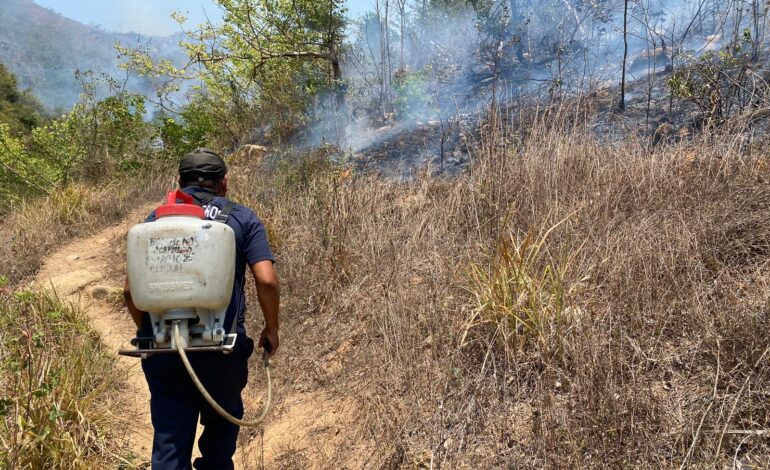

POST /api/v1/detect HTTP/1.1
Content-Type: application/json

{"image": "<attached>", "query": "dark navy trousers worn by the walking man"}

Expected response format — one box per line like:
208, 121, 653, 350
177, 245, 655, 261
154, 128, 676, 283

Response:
142, 335, 254, 470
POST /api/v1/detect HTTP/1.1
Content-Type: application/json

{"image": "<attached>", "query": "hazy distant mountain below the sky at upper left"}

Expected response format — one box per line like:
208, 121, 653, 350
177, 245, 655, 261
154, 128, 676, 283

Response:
0, 0, 186, 110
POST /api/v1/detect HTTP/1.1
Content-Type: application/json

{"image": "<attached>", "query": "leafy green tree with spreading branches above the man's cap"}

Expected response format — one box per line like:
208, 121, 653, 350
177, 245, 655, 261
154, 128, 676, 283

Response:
119, 0, 345, 145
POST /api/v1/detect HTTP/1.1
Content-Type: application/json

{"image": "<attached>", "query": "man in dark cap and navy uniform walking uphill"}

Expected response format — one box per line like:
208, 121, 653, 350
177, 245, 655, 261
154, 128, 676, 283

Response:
124, 148, 279, 470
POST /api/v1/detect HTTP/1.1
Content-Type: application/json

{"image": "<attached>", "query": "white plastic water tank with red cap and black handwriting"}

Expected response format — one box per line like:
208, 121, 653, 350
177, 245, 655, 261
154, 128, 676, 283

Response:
127, 191, 235, 313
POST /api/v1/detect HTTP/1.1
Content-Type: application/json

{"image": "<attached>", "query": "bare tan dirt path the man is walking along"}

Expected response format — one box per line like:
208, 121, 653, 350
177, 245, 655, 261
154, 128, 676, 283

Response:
34, 207, 372, 469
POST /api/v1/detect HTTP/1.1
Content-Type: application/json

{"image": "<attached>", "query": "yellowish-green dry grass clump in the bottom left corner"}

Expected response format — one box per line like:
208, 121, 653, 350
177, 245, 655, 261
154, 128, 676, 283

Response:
0, 292, 124, 469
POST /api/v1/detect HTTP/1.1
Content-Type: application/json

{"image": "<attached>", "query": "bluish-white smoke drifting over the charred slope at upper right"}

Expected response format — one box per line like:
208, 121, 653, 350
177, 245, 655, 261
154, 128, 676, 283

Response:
295, 0, 764, 160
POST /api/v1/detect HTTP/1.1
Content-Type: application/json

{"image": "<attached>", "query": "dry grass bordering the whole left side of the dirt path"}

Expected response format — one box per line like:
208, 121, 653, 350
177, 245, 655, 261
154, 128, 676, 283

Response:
0, 160, 172, 469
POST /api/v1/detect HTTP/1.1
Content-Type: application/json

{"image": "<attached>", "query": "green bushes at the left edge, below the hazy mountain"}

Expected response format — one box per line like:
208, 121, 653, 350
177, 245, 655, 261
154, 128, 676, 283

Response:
0, 89, 153, 207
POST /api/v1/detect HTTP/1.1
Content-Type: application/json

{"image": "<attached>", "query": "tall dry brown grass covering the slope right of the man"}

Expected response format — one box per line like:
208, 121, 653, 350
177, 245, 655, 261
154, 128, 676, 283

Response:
232, 104, 770, 468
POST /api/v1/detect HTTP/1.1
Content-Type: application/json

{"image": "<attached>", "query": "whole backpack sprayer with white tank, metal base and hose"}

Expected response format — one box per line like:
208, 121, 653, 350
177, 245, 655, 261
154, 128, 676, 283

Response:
118, 190, 273, 427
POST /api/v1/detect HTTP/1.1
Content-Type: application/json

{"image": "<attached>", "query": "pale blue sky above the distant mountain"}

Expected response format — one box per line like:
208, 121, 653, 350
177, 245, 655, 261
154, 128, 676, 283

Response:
33, 0, 375, 36
